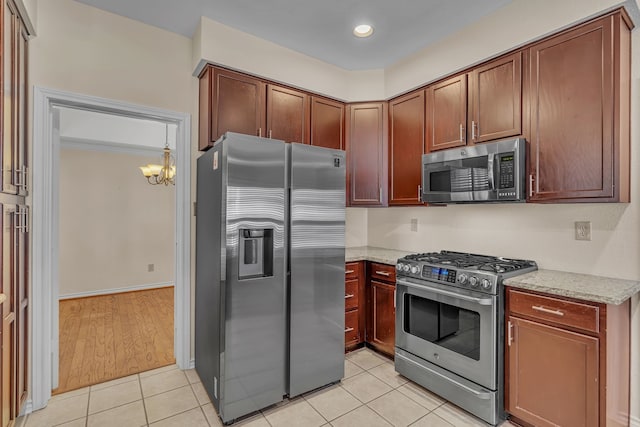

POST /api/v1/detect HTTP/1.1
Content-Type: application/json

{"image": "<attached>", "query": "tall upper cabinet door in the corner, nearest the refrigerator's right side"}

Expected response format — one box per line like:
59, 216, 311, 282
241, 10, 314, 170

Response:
346, 102, 387, 206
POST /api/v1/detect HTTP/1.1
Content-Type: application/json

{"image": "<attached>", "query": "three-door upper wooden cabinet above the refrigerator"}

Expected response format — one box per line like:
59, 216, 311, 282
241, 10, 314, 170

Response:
198, 65, 344, 151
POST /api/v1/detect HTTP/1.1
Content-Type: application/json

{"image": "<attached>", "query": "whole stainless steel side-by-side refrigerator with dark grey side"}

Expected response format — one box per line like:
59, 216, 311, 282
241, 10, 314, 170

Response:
195, 133, 345, 423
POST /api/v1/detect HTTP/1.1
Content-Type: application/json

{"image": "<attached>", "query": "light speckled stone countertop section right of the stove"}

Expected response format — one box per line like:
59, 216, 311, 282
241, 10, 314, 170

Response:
504, 270, 640, 305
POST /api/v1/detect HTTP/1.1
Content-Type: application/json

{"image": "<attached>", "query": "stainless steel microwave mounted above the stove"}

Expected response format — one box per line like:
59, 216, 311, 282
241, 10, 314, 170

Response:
421, 138, 526, 204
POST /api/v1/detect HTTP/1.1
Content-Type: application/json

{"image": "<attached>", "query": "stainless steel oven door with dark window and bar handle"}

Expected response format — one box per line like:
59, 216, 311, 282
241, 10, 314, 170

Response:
396, 278, 498, 390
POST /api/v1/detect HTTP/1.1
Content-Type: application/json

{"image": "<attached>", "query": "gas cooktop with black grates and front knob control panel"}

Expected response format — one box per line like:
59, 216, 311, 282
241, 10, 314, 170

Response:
396, 251, 538, 294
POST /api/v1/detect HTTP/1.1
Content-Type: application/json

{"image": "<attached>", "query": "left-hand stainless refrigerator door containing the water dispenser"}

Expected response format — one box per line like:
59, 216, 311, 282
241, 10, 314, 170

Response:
220, 134, 287, 422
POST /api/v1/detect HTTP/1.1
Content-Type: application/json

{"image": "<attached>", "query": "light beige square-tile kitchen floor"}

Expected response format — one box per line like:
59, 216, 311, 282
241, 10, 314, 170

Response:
17, 349, 510, 427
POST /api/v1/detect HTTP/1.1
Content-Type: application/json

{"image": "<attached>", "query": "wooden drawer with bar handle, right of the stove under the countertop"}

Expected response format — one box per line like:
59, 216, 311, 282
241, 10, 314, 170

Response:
509, 289, 600, 333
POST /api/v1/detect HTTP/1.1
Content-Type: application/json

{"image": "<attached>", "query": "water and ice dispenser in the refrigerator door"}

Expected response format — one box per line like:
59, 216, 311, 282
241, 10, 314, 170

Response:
238, 228, 273, 279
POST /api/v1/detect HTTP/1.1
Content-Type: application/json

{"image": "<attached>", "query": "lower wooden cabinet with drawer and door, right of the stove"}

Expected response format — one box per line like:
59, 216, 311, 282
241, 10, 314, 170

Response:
505, 288, 630, 427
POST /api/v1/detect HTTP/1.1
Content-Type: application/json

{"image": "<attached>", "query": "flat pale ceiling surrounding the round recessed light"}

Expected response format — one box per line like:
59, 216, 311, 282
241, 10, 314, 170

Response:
77, 0, 512, 70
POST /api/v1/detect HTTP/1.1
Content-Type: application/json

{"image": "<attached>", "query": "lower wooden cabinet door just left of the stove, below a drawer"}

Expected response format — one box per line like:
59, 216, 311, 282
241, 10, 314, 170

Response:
367, 280, 396, 355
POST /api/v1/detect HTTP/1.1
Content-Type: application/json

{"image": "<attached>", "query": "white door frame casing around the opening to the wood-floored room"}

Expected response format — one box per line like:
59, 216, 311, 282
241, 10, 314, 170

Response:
30, 86, 191, 413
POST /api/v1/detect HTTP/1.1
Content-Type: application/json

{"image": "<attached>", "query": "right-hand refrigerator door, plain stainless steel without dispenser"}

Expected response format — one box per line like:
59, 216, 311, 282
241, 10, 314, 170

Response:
289, 144, 345, 396
